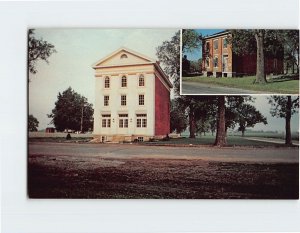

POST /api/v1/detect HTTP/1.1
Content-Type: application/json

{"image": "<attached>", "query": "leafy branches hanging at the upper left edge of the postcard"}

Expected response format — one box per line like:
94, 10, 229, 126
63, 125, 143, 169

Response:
28, 29, 56, 78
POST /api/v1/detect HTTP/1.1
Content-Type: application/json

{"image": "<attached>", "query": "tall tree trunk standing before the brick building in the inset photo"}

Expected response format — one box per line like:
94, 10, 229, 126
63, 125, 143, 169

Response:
255, 30, 267, 84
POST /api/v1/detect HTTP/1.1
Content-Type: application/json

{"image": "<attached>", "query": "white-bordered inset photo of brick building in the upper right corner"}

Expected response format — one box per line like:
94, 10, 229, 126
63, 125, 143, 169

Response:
180, 29, 299, 95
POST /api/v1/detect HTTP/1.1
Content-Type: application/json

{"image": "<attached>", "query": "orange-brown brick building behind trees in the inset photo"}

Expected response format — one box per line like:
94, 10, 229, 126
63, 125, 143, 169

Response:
202, 31, 283, 77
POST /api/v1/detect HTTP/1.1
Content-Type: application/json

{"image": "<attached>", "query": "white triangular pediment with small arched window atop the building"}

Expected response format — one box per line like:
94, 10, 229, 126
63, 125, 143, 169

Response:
93, 48, 155, 68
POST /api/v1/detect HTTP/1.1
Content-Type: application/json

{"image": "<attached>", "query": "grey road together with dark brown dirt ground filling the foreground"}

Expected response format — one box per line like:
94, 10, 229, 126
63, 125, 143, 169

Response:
28, 143, 299, 199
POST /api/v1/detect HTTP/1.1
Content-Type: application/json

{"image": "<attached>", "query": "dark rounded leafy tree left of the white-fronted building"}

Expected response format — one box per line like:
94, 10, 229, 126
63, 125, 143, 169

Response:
48, 87, 94, 132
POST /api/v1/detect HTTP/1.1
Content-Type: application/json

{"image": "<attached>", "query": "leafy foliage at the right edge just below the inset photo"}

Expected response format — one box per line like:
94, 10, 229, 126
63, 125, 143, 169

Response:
269, 95, 299, 118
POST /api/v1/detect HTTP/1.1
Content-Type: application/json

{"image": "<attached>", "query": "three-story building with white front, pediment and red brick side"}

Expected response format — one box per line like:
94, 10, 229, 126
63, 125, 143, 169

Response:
93, 48, 172, 141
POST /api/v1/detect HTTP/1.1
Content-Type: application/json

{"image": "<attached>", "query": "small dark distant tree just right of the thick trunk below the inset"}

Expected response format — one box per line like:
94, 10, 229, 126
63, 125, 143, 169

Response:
237, 103, 267, 137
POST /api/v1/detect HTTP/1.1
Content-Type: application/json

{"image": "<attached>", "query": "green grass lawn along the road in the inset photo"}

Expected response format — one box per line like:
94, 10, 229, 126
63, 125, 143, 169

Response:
182, 76, 299, 94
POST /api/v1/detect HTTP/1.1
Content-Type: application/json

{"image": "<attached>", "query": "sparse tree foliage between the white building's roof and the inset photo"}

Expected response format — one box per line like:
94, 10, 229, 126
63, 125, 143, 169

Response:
156, 31, 180, 95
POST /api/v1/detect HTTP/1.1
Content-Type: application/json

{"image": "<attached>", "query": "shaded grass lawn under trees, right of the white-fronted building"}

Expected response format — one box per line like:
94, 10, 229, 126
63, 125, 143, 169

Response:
145, 135, 290, 147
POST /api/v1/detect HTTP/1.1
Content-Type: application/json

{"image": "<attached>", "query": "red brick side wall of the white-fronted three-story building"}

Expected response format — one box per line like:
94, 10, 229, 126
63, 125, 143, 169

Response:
155, 77, 170, 136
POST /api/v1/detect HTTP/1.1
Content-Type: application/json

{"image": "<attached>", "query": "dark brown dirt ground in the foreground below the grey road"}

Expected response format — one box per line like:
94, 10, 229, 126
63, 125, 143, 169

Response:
28, 151, 299, 199
